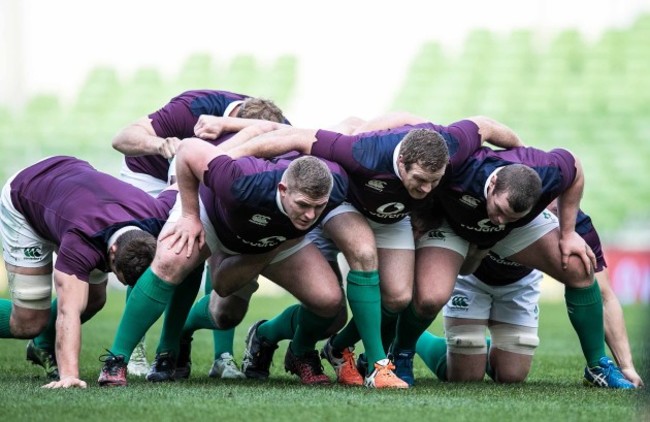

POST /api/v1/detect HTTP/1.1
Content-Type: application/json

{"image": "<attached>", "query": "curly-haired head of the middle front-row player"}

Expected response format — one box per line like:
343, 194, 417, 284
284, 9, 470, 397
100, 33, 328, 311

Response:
397, 129, 449, 199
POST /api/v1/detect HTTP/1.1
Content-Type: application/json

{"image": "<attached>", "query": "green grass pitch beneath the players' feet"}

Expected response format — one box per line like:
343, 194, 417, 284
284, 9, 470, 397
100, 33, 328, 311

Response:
0, 291, 649, 421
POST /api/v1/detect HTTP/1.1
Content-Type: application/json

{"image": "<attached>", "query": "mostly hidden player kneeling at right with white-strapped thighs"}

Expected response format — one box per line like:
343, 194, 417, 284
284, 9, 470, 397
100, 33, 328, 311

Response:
416, 207, 643, 387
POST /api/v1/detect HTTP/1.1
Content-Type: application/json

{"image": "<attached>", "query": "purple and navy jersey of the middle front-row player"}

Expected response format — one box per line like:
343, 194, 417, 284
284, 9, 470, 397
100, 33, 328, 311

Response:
311, 120, 481, 224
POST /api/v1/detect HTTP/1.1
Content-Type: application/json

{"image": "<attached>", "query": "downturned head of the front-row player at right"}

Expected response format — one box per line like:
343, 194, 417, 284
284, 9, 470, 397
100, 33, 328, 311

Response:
486, 164, 542, 225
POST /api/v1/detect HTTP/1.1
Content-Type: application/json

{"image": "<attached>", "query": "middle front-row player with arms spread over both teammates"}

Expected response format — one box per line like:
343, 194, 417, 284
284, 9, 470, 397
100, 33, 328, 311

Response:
205, 113, 520, 388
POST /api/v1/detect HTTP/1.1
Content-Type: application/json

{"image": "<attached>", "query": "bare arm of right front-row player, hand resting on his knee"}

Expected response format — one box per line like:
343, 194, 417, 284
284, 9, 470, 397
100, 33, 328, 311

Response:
557, 157, 596, 274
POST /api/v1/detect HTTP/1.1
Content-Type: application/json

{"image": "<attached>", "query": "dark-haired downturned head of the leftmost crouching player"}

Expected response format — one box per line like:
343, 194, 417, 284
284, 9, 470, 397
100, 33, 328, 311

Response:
110, 230, 156, 286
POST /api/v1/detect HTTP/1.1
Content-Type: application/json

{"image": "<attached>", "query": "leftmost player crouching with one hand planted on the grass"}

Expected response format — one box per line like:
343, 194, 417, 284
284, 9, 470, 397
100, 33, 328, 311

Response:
0, 156, 176, 388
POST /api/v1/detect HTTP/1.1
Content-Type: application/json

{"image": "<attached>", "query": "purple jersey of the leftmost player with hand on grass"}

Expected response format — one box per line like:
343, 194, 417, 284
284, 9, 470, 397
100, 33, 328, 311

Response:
11, 156, 176, 281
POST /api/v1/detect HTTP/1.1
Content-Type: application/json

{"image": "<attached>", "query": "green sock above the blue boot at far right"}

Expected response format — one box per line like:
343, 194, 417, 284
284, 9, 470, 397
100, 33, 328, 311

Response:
564, 280, 605, 367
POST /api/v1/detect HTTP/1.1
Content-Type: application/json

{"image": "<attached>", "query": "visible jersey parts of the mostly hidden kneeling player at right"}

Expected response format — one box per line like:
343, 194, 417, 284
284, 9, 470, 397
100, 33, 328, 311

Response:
474, 211, 607, 286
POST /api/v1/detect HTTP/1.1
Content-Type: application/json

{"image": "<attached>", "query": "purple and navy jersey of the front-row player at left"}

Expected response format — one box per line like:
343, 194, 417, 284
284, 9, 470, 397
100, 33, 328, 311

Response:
199, 155, 348, 254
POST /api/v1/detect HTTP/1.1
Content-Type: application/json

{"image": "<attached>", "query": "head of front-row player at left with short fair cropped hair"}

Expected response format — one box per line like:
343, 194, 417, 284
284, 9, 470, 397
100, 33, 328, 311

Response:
278, 156, 334, 230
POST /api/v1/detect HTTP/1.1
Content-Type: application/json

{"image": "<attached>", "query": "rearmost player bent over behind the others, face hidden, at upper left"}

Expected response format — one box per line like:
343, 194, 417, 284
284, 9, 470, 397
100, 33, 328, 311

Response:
113, 90, 286, 378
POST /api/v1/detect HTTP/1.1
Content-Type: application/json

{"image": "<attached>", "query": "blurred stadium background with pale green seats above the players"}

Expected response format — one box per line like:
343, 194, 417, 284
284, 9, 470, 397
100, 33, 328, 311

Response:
0, 0, 650, 303
